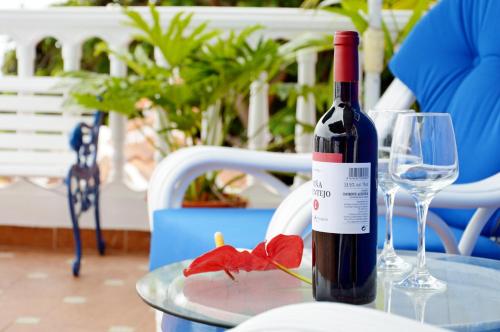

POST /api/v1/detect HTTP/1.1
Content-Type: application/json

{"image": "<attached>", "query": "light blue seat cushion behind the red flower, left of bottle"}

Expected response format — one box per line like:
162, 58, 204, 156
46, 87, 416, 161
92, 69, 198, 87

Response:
149, 209, 274, 270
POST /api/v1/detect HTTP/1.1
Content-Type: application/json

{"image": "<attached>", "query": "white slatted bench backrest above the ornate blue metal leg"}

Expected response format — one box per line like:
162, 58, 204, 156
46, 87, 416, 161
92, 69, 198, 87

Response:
0, 77, 92, 177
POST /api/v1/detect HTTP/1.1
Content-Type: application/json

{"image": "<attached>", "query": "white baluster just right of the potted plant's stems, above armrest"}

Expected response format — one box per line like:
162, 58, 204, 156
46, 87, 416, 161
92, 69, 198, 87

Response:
248, 72, 271, 150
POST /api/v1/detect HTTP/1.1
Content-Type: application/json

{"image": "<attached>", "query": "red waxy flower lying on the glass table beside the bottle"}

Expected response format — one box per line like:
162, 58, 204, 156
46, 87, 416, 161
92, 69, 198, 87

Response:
184, 234, 304, 277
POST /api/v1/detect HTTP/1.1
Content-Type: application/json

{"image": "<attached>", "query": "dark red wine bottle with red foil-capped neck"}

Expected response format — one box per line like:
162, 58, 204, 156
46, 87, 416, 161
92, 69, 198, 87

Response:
312, 31, 377, 304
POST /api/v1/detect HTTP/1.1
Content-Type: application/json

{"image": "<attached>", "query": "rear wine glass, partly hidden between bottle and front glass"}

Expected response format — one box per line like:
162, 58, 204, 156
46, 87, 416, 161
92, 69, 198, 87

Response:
368, 110, 414, 272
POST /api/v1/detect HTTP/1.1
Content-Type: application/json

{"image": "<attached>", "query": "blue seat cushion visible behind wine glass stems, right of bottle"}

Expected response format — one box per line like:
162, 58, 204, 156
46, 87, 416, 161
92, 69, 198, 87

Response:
377, 216, 500, 259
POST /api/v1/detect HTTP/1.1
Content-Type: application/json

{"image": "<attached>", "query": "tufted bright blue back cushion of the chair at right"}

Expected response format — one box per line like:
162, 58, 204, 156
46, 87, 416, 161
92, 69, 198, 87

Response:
390, 0, 500, 235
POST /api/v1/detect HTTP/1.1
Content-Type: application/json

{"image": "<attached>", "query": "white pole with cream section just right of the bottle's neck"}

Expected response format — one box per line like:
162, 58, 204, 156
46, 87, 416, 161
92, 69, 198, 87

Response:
363, 0, 384, 111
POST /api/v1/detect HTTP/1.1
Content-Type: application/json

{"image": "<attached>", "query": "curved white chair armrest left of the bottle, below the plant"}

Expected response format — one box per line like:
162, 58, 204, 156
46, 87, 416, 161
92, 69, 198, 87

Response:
148, 146, 311, 229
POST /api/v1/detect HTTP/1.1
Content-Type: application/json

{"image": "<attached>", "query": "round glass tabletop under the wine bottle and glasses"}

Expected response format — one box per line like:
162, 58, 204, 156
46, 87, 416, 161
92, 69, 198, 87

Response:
136, 251, 500, 331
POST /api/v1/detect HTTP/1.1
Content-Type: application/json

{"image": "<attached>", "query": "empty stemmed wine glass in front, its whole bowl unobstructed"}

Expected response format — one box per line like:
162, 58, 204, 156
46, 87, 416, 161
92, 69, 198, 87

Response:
389, 113, 458, 291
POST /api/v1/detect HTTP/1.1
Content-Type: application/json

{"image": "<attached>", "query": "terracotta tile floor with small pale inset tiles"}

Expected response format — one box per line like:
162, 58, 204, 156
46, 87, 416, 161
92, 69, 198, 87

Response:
0, 247, 154, 332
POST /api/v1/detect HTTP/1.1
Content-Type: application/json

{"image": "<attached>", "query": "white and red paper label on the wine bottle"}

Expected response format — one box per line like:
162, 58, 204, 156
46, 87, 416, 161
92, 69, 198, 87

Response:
312, 152, 371, 234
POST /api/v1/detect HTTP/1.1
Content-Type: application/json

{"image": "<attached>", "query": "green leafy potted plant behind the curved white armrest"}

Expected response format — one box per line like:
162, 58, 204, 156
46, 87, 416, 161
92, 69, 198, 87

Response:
65, 6, 286, 206
